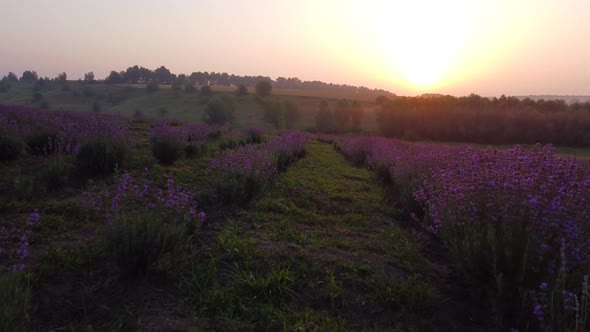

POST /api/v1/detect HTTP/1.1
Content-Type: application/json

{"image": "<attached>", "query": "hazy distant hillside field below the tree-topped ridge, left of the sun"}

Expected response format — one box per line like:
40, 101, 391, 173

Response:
0, 82, 377, 131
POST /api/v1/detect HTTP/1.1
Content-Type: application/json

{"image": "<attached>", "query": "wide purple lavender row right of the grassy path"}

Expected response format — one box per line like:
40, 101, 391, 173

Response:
341, 137, 590, 330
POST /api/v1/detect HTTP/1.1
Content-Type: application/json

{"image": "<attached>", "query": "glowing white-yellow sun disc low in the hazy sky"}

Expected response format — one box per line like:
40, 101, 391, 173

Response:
373, 0, 473, 91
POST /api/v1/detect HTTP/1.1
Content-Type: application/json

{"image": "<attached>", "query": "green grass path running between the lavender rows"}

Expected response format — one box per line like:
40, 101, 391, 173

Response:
189, 141, 435, 331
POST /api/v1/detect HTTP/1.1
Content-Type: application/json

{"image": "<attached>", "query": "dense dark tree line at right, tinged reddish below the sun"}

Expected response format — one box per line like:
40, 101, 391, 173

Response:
376, 94, 590, 146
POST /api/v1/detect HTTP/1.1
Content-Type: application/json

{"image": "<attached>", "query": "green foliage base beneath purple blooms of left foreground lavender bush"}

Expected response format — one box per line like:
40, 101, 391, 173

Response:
106, 211, 186, 278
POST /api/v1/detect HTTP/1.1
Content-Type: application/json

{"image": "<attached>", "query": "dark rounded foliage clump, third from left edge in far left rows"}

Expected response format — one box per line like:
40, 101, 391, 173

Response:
75, 137, 128, 176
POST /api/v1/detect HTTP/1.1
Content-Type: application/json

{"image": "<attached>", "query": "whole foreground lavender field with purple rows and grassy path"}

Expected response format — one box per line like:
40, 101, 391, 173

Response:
0, 102, 590, 331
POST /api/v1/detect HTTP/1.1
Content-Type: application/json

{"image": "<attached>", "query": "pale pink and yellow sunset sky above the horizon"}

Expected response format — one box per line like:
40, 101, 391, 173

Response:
0, 0, 590, 96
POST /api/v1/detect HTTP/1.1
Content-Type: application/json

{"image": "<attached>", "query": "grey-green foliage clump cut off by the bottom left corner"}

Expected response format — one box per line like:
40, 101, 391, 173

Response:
0, 272, 31, 331
